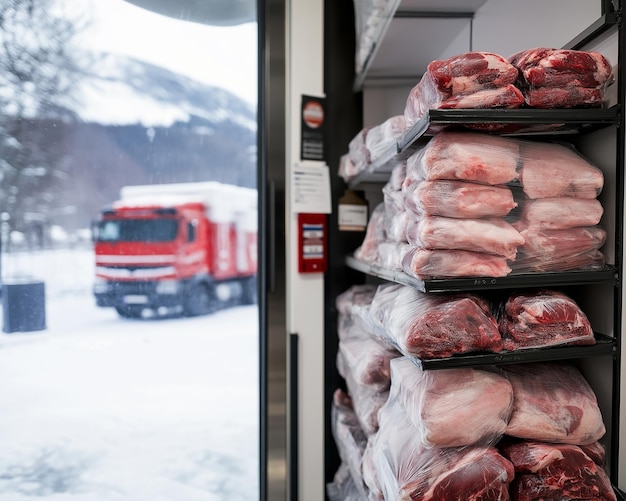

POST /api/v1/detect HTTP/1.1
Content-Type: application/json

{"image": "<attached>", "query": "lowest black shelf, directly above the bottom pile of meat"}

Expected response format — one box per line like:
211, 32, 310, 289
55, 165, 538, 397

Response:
405, 333, 617, 370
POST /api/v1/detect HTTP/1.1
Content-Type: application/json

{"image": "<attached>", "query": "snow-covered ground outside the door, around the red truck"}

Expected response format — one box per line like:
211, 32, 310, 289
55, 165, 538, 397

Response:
0, 250, 259, 501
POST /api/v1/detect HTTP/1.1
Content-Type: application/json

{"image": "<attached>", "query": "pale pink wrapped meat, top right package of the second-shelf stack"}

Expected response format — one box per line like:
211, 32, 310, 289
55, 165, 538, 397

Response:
520, 141, 604, 199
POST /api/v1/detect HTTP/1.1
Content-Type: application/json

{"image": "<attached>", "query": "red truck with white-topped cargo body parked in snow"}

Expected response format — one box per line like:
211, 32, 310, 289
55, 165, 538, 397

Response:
93, 182, 257, 318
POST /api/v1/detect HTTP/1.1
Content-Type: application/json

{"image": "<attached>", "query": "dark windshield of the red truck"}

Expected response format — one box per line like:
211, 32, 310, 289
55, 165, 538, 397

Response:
96, 219, 178, 242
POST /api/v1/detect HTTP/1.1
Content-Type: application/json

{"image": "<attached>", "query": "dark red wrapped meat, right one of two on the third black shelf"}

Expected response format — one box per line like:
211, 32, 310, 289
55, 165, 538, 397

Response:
499, 289, 596, 350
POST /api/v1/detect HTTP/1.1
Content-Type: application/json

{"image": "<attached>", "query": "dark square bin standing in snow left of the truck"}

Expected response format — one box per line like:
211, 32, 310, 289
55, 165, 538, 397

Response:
2, 280, 46, 332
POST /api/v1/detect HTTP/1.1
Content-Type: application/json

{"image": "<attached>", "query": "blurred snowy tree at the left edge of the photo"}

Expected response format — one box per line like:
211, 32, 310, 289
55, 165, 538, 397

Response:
0, 0, 84, 246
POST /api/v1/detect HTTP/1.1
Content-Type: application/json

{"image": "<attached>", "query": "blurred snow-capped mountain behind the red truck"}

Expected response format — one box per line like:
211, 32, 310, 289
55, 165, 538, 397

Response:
37, 55, 257, 230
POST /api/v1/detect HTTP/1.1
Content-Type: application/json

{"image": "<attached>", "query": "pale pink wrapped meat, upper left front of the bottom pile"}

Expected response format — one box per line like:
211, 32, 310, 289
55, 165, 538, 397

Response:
389, 357, 513, 447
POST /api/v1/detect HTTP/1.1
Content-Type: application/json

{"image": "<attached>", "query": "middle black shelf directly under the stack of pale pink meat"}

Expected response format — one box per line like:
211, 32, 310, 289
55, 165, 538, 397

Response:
346, 256, 618, 292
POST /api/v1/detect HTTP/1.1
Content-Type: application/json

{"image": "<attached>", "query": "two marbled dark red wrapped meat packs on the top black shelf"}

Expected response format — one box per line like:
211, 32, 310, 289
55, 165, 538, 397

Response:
404, 47, 614, 132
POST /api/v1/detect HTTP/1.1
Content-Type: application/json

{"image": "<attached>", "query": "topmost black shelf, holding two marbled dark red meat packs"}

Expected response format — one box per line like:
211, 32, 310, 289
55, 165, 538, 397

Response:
398, 105, 619, 153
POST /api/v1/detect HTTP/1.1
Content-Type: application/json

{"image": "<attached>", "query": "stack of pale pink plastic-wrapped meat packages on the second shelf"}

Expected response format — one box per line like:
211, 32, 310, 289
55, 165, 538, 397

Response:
354, 127, 606, 280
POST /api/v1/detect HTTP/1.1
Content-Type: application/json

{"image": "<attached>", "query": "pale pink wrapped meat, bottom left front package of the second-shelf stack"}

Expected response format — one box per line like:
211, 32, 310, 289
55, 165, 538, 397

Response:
402, 247, 512, 280
